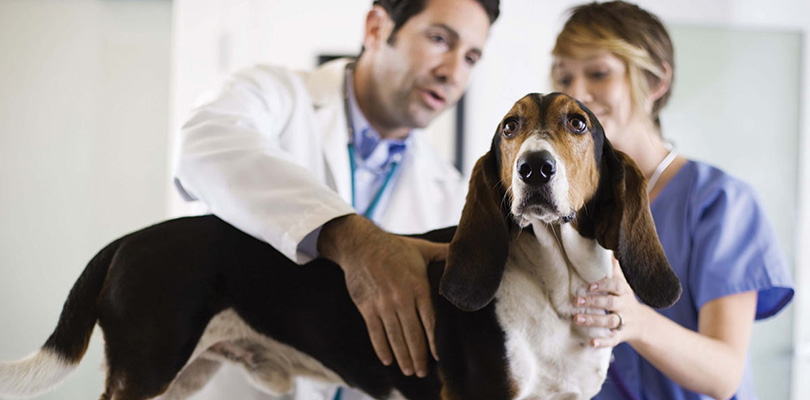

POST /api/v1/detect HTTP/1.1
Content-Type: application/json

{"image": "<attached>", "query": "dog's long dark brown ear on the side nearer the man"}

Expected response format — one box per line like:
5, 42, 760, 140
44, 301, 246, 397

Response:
439, 143, 509, 311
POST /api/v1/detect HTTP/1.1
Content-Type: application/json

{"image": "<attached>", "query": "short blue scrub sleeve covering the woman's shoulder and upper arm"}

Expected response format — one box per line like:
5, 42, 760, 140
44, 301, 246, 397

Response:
687, 161, 793, 319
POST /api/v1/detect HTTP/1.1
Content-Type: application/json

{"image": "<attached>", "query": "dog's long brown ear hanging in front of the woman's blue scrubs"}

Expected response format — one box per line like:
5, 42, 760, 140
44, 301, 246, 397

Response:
580, 133, 681, 308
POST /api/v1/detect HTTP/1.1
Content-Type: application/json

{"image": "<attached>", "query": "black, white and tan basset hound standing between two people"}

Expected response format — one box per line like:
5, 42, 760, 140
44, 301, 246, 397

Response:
0, 94, 681, 400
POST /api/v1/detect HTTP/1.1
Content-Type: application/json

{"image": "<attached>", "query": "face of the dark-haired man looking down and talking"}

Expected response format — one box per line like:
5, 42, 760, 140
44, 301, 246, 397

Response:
366, 0, 489, 128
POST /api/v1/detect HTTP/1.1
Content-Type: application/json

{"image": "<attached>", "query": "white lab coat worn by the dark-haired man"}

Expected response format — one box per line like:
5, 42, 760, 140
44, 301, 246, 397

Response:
175, 59, 466, 400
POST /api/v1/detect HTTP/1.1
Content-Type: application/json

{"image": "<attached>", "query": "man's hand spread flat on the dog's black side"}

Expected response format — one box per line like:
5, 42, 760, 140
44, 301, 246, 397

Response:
318, 214, 448, 377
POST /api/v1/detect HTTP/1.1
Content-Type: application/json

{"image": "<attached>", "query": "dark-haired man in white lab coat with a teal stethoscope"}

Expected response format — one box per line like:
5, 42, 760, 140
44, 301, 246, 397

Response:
175, 0, 498, 400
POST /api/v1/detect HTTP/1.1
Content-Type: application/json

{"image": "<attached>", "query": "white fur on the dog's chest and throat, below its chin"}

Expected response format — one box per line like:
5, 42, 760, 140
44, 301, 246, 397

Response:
495, 223, 612, 399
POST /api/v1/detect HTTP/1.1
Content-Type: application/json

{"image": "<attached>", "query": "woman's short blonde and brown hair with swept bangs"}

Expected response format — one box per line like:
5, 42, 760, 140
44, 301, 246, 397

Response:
552, 1, 675, 127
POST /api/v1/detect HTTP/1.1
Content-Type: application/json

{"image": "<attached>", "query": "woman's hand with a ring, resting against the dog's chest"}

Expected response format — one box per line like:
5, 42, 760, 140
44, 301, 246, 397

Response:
574, 258, 646, 348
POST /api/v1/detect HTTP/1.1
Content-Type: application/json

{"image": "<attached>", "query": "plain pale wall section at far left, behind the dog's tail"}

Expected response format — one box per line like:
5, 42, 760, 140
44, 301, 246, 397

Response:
0, 0, 171, 399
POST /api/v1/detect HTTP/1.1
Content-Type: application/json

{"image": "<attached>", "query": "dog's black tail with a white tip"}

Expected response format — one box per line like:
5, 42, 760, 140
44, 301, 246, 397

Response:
0, 238, 123, 399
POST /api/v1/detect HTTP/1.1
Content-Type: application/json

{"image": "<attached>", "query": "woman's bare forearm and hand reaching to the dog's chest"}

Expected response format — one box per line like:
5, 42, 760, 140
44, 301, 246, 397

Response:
574, 259, 757, 399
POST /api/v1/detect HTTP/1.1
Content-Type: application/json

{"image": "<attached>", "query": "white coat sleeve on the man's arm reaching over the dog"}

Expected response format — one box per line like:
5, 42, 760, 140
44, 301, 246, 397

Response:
175, 68, 354, 262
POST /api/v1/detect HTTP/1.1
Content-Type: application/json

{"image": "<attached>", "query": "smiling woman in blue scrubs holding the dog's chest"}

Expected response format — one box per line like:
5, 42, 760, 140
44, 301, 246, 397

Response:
552, 1, 793, 400
